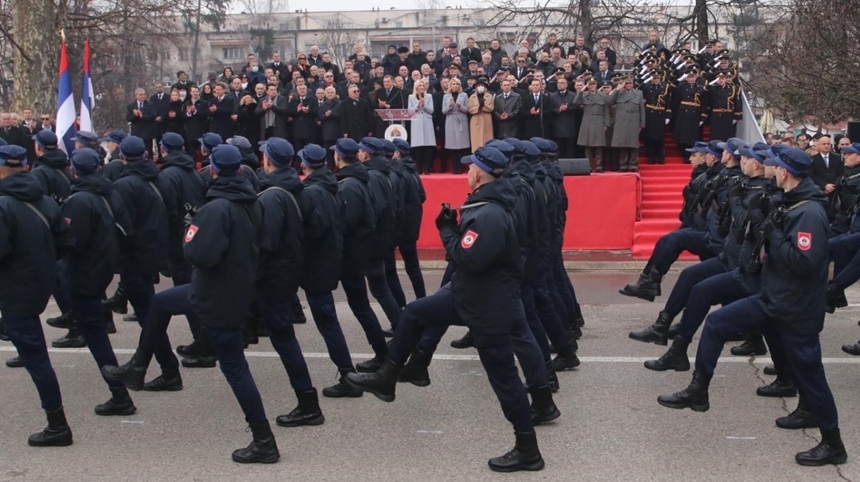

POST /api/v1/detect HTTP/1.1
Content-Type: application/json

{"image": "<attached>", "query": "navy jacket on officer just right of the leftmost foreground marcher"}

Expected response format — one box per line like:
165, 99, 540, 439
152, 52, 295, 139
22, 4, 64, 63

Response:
62, 174, 133, 298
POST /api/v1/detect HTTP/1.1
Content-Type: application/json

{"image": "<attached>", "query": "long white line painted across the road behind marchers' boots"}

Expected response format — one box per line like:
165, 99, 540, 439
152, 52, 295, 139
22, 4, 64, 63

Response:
5, 346, 860, 365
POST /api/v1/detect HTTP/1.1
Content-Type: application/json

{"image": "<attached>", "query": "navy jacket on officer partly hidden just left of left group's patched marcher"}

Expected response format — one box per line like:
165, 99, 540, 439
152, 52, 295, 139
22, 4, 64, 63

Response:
158, 151, 206, 259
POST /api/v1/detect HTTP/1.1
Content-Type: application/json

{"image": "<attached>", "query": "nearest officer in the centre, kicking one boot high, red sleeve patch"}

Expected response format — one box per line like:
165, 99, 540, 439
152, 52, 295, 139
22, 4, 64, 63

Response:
347, 147, 544, 472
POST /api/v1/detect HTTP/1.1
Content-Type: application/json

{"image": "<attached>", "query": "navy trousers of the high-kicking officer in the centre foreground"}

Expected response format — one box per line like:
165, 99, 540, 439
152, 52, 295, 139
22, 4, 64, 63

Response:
388, 285, 546, 432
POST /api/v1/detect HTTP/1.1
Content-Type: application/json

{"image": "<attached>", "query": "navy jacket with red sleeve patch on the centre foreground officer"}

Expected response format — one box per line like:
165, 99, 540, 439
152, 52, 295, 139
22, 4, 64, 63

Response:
439, 178, 523, 334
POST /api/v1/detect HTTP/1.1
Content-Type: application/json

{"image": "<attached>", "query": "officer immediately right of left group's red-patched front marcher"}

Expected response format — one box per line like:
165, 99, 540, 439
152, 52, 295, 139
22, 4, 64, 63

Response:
257, 137, 325, 427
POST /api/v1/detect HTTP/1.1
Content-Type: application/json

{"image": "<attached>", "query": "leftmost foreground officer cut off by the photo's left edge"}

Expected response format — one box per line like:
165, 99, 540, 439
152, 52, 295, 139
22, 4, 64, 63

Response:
0, 145, 74, 447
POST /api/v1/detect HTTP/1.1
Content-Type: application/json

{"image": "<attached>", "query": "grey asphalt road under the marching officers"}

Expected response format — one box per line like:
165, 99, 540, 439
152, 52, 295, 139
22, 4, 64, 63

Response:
0, 271, 860, 482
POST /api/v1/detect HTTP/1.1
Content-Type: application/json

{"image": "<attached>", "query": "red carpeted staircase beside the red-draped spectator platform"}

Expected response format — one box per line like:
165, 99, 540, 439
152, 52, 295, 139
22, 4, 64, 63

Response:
633, 129, 698, 259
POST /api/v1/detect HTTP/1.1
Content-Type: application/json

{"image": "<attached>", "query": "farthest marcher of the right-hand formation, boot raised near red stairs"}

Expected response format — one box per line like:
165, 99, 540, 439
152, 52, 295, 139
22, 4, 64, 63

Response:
619, 141, 727, 306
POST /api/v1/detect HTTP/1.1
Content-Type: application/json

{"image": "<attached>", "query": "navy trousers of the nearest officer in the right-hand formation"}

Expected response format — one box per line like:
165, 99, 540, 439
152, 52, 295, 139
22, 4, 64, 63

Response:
696, 295, 839, 431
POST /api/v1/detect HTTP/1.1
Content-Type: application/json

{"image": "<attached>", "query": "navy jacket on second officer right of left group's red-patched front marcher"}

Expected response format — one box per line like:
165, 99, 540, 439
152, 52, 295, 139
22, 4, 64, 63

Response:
301, 167, 344, 293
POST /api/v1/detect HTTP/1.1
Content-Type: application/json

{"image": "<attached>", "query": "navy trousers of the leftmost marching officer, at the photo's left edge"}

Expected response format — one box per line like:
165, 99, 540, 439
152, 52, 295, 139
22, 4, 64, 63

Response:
2, 313, 63, 412
